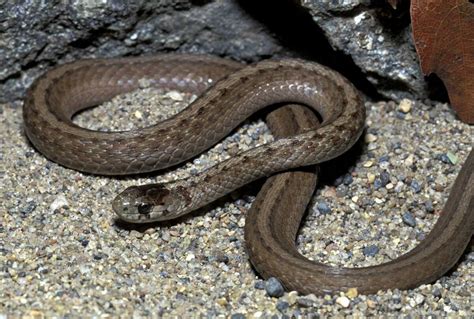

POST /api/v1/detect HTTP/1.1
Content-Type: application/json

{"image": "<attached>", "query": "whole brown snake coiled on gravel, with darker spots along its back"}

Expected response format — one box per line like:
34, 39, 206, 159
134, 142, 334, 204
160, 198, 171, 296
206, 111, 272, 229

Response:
23, 54, 474, 294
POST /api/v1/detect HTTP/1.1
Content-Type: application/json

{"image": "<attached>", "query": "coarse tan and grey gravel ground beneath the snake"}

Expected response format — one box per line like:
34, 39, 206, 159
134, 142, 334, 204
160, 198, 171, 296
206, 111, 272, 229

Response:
0, 89, 474, 318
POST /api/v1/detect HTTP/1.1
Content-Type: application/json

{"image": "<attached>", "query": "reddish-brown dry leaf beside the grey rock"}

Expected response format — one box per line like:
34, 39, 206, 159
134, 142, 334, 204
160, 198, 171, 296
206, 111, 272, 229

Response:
411, 0, 474, 124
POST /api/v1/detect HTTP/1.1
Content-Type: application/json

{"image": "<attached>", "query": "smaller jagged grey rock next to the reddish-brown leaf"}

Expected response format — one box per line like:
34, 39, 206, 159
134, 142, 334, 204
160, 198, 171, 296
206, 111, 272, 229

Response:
302, 0, 429, 100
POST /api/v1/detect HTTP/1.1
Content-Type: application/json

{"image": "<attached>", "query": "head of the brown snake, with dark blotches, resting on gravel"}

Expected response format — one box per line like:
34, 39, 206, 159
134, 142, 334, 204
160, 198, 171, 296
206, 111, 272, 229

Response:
112, 184, 187, 223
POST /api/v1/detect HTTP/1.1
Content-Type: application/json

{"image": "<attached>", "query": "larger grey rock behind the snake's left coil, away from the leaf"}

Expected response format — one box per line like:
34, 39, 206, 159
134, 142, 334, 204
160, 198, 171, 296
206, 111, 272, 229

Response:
0, 0, 282, 102
